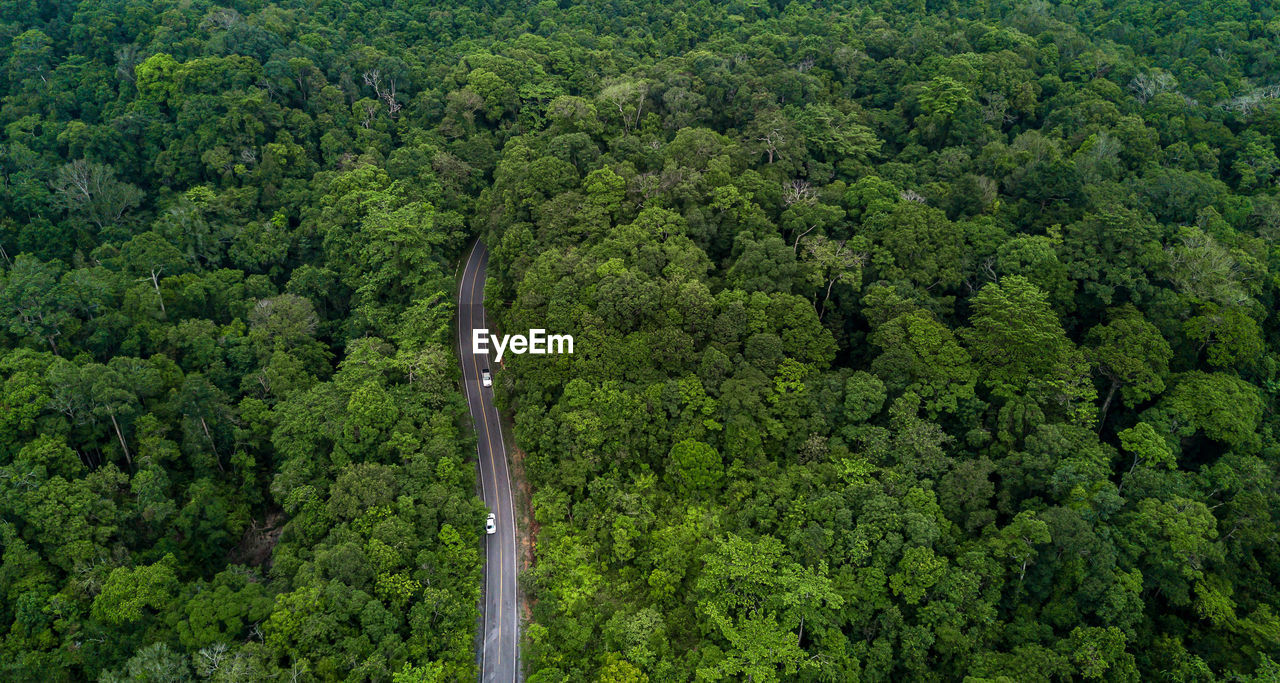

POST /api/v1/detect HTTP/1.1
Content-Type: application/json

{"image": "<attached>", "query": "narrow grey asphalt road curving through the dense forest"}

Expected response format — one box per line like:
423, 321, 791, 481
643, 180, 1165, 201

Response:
458, 242, 520, 683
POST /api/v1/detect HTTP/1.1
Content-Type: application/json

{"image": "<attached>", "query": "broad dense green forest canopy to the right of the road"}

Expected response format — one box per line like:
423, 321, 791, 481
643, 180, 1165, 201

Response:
471, 3, 1280, 683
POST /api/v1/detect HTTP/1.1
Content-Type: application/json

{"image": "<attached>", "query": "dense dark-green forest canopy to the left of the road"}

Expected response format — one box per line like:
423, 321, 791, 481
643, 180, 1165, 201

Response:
0, 1, 484, 680
